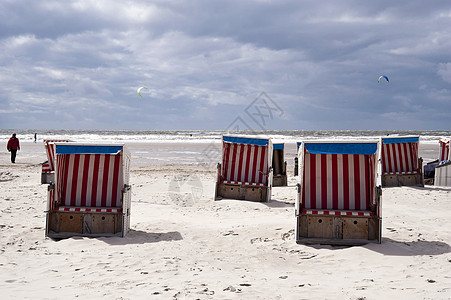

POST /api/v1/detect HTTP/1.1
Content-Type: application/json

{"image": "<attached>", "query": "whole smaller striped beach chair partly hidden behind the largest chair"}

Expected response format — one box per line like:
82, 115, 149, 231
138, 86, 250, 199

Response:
381, 136, 424, 187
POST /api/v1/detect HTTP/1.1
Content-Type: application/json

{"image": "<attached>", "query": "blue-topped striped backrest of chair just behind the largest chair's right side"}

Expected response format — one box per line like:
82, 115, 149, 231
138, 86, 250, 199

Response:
381, 137, 420, 174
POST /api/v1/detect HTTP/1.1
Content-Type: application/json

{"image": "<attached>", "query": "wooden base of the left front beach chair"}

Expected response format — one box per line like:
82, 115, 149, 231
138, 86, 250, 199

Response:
46, 212, 125, 238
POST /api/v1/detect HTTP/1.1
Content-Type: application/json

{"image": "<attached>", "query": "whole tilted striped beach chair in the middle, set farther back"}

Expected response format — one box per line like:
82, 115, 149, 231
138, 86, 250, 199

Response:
215, 136, 273, 202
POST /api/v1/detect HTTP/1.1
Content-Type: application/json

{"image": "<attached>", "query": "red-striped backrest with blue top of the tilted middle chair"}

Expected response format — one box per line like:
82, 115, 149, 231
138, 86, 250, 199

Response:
221, 136, 272, 185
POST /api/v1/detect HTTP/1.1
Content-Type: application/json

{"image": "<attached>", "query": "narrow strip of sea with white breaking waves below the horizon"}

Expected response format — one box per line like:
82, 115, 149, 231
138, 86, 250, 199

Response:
0, 129, 451, 144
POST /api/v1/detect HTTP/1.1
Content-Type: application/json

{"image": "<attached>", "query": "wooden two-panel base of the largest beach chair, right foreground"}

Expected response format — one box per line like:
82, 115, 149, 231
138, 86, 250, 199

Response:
296, 215, 381, 245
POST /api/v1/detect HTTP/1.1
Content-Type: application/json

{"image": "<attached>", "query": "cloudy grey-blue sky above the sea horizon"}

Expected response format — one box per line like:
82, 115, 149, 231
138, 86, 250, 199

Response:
0, 0, 451, 130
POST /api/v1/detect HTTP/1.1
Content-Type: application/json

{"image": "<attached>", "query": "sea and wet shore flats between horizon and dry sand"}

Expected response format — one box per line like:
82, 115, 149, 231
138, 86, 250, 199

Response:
0, 129, 451, 166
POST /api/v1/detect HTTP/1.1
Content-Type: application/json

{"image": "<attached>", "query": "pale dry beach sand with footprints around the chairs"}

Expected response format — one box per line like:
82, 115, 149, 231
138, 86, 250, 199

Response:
0, 143, 451, 299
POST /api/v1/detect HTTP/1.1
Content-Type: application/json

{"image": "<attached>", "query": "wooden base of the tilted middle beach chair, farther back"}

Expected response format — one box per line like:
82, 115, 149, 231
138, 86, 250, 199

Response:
215, 183, 268, 202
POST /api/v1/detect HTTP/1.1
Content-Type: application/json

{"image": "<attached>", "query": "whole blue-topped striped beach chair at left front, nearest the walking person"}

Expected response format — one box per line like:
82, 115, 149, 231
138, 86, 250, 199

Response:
46, 143, 131, 238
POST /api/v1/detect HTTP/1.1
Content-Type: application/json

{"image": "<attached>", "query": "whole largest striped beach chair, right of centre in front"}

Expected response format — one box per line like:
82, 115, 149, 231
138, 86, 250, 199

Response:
295, 141, 382, 245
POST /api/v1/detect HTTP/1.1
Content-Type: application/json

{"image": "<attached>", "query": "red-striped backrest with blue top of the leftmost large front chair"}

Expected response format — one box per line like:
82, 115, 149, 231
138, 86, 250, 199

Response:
55, 143, 128, 207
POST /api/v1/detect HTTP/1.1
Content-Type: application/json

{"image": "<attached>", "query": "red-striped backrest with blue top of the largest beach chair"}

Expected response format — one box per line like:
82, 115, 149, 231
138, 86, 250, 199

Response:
300, 142, 378, 210
